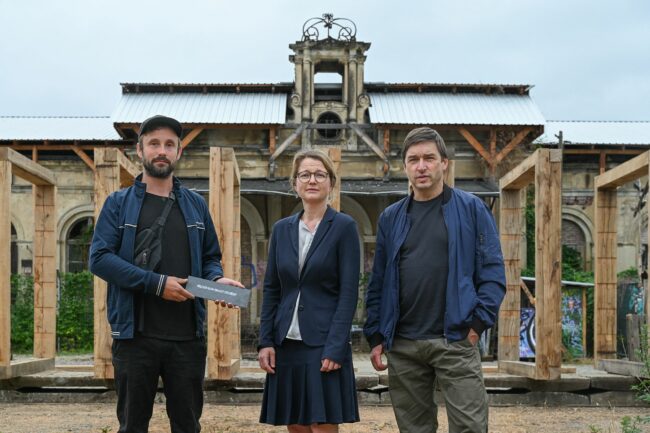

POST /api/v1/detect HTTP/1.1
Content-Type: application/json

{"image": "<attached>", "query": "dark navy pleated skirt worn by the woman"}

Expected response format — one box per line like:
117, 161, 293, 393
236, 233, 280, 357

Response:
260, 340, 359, 425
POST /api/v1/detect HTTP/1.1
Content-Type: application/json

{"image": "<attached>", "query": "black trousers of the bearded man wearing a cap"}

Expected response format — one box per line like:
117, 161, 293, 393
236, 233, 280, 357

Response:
113, 336, 206, 433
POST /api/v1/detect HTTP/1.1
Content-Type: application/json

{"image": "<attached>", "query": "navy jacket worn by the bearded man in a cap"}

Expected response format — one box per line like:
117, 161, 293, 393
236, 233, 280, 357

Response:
90, 175, 223, 339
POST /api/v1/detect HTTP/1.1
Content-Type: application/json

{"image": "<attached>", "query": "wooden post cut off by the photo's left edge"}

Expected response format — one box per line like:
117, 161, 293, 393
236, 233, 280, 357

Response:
0, 160, 11, 368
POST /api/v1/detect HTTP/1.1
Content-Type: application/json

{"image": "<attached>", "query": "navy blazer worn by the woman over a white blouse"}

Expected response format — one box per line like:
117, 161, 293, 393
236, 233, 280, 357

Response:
259, 206, 359, 364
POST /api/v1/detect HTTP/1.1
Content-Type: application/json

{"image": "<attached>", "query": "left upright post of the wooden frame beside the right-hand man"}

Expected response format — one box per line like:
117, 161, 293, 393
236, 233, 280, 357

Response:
498, 189, 526, 361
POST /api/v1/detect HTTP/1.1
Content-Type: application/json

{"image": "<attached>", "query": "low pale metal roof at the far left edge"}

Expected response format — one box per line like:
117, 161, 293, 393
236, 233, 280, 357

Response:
0, 116, 122, 141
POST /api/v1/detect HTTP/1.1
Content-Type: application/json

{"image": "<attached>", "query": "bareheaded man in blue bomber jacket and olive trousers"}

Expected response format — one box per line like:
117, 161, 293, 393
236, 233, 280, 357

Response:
364, 127, 505, 433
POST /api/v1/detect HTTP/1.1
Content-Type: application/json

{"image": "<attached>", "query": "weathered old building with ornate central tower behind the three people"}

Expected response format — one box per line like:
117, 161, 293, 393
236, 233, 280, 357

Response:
0, 17, 650, 354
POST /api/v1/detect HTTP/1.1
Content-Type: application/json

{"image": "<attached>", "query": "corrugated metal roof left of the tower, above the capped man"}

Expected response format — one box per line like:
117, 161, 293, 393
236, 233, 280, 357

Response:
111, 93, 287, 124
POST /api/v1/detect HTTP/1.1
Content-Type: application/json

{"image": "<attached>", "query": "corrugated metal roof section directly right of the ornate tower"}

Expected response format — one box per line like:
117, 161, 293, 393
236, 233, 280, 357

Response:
370, 93, 545, 125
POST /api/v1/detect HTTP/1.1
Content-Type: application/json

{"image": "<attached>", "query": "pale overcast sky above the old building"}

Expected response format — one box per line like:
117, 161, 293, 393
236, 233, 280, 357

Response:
0, 0, 650, 120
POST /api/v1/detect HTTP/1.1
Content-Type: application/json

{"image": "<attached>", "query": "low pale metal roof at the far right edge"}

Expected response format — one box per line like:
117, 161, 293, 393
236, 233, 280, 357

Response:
536, 120, 650, 146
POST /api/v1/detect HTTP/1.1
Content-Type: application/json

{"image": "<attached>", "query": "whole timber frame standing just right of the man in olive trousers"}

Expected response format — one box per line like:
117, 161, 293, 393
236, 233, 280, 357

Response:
498, 149, 562, 380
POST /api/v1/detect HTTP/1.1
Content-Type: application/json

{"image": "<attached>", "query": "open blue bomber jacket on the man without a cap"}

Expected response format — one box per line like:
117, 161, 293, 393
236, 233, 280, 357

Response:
364, 185, 506, 350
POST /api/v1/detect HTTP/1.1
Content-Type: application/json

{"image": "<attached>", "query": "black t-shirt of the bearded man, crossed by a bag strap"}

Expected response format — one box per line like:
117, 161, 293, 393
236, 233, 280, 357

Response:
135, 193, 192, 341
